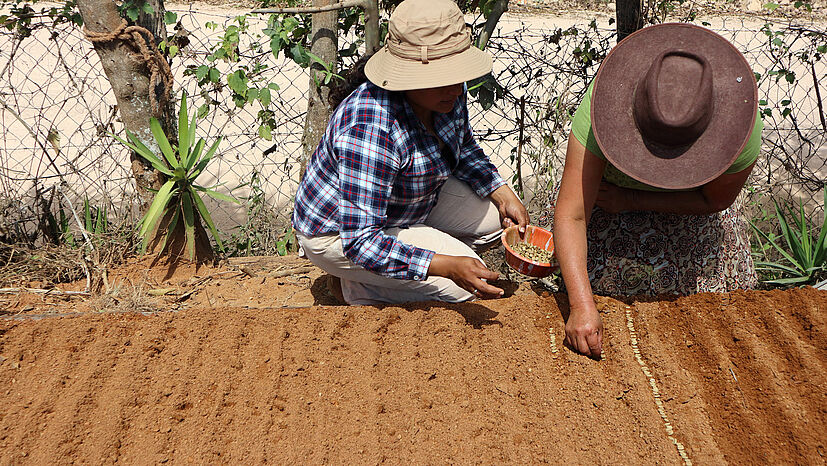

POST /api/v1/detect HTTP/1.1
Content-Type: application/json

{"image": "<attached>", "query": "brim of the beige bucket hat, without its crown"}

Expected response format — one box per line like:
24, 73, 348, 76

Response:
365, 46, 493, 91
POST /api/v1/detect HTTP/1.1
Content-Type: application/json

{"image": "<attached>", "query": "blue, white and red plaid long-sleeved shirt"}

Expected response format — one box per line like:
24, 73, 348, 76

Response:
293, 81, 505, 280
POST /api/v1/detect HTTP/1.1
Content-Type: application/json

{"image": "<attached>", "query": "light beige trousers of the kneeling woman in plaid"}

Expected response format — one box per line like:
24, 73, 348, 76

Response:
296, 177, 502, 304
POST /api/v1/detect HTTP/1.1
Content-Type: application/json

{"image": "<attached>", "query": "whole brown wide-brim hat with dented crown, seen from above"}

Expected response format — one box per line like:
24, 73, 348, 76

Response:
591, 23, 758, 189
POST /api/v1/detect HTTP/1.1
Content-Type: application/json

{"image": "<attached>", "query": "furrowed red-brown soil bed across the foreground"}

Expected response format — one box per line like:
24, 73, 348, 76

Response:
0, 258, 827, 464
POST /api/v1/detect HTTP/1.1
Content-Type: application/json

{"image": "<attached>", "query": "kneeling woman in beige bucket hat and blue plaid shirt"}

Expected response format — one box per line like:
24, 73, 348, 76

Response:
293, 0, 529, 304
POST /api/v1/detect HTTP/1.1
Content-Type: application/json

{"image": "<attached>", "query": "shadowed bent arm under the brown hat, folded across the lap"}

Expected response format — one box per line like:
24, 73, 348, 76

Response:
597, 163, 755, 215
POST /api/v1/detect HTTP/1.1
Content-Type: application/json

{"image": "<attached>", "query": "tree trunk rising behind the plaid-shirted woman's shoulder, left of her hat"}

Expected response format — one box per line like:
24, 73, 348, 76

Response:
300, 0, 339, 178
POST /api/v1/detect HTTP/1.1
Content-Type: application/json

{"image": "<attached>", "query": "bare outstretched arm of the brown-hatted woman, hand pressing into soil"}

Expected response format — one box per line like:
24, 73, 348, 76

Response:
554, 134, 606, 358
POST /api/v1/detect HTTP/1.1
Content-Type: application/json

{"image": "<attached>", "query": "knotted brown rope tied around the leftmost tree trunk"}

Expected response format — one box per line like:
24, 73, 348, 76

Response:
83, 19, 172, 115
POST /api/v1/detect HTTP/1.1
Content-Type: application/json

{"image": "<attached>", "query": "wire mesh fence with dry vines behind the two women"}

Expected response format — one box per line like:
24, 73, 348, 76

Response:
0, 4, 827, 254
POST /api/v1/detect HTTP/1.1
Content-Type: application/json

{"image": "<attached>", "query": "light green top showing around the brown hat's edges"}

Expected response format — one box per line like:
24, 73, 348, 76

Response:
571, 81, 764, 191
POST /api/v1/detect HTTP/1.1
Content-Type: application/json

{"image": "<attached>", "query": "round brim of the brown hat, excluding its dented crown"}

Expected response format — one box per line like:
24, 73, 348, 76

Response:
591, 23, 758, 189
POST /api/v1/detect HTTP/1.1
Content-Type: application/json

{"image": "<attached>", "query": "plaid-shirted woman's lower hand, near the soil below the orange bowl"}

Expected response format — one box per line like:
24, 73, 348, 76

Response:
428, 254, 504, 298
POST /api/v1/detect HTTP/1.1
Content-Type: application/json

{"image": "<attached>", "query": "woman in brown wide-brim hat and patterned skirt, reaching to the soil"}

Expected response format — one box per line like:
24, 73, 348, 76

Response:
554, 24, 763, 357
